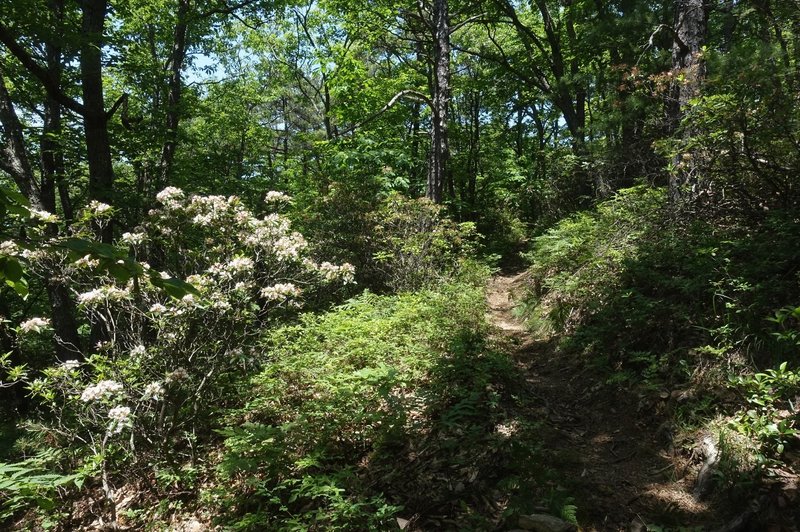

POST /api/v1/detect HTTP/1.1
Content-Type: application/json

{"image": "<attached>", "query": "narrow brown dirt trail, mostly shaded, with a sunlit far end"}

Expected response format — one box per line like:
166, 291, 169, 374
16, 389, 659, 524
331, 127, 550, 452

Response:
487, 274, 715, 531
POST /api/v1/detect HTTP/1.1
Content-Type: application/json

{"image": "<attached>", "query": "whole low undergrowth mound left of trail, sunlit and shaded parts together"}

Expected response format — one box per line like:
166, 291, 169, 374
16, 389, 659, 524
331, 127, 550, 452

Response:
205, 276, 558, 530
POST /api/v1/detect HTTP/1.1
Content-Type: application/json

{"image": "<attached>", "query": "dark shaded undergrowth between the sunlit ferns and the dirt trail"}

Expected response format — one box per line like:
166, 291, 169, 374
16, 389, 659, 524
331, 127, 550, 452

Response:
358, 335, 552, 530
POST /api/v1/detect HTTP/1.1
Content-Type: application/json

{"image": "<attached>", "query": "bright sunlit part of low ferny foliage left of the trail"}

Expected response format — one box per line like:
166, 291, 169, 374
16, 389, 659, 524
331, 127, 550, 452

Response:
216, 285, 483, 528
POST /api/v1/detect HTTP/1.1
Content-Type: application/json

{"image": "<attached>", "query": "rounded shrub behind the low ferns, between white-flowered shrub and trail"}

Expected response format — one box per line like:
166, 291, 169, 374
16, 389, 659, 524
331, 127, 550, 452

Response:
292, 189, 478, 292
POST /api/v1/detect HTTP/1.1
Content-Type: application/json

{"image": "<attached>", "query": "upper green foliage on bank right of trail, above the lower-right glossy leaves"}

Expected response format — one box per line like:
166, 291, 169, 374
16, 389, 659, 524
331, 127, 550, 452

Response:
525, 188, 800, 388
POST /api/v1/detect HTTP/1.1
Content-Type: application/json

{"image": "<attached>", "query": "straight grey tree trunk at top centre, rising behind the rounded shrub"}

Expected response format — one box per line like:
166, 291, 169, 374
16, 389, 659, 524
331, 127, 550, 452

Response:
426, 0, 450, 203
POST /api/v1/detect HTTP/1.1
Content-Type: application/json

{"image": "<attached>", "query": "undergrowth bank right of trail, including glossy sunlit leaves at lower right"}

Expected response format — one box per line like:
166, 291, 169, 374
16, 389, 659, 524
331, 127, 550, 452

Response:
522, 186, 800, 494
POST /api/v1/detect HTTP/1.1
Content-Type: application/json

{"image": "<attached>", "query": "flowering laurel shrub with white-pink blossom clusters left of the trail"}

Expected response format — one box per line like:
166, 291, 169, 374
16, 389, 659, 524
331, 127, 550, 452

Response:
10, 187, 354, 502
